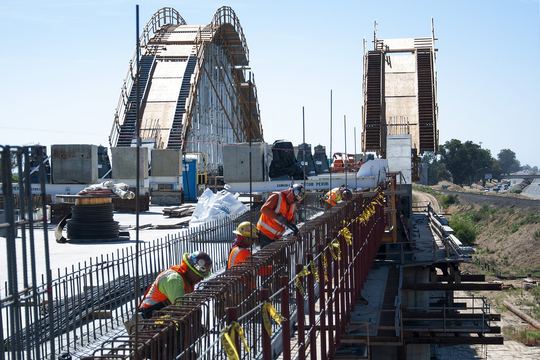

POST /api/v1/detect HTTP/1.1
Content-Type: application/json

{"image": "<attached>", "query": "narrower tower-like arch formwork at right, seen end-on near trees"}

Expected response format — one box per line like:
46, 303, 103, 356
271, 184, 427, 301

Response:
362, 32, 438, 155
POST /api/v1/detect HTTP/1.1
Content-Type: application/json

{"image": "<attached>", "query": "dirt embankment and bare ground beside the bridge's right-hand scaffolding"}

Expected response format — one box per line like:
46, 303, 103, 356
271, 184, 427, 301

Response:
413, 186, 540, 352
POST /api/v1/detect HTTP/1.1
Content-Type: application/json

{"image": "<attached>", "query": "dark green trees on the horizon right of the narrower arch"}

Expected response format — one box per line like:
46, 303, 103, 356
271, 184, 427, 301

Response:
422, 139, 521, 185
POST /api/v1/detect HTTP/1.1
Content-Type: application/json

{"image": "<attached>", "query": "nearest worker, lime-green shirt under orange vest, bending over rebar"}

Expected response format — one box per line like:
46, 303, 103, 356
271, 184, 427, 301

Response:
139, 251, 212, 319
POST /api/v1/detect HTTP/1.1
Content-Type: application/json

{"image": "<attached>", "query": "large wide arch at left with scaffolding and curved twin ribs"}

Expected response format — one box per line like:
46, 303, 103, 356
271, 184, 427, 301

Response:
109, 6, 263, 172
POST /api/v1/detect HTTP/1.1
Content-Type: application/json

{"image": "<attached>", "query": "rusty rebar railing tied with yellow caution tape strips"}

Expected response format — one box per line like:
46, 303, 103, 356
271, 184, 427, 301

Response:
78, 193, 384, 360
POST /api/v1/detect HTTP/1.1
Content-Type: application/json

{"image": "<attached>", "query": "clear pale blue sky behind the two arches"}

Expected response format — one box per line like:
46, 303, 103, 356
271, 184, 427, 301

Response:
0, 0, 540, 166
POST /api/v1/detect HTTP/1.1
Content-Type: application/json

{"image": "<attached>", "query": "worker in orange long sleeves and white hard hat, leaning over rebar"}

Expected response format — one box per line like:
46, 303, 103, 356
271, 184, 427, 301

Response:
257, 184, 306, 249
